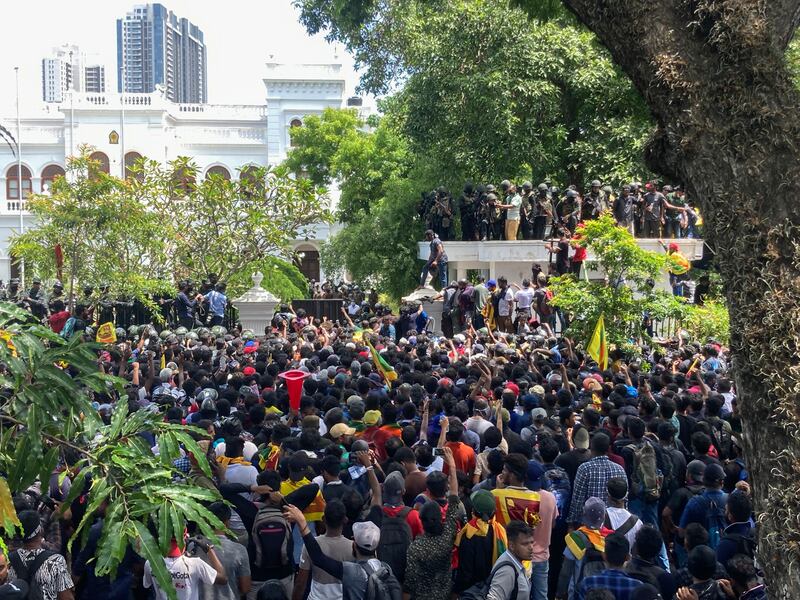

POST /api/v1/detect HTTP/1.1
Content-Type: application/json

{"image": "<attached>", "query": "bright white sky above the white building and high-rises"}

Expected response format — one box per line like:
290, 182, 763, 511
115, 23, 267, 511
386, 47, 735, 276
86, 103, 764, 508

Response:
0, 0, 364, 116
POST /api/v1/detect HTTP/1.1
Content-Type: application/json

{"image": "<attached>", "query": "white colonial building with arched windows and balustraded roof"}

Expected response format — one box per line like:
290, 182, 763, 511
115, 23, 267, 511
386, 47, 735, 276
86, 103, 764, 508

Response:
0, 63, 361, 281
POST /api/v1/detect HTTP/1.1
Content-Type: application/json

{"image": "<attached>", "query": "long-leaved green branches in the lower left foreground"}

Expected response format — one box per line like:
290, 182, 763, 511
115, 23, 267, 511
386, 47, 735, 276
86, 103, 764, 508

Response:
0, 303, 222, 598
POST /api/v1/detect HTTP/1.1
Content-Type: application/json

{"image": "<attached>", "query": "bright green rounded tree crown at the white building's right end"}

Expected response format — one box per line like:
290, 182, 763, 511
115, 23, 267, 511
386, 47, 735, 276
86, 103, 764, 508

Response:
284, 108, 408, 223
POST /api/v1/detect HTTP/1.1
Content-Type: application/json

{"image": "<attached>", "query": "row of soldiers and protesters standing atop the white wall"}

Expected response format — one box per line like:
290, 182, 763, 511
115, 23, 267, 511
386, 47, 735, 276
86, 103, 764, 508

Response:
418, 179, 702, 242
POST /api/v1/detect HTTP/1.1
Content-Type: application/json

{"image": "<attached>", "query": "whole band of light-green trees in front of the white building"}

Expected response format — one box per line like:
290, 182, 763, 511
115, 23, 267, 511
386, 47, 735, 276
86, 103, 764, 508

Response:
11, 147, 330, 304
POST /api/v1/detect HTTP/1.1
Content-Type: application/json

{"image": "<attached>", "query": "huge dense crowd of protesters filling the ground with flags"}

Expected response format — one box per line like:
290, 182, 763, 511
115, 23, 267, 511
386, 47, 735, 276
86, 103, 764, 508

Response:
0, 281, 766, 600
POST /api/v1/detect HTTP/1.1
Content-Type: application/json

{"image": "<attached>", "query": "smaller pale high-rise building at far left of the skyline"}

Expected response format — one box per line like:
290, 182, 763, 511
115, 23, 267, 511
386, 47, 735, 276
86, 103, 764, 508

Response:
42, 44, 106, 102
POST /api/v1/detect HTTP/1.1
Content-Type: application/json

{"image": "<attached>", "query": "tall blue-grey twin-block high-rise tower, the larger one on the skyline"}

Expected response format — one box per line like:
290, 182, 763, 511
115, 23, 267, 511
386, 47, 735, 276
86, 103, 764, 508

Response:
117, 4, 208, 103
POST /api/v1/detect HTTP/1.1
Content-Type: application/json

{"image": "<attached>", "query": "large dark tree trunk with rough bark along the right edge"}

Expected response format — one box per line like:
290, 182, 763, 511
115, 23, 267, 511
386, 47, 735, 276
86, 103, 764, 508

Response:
556, 0, 800, 598
